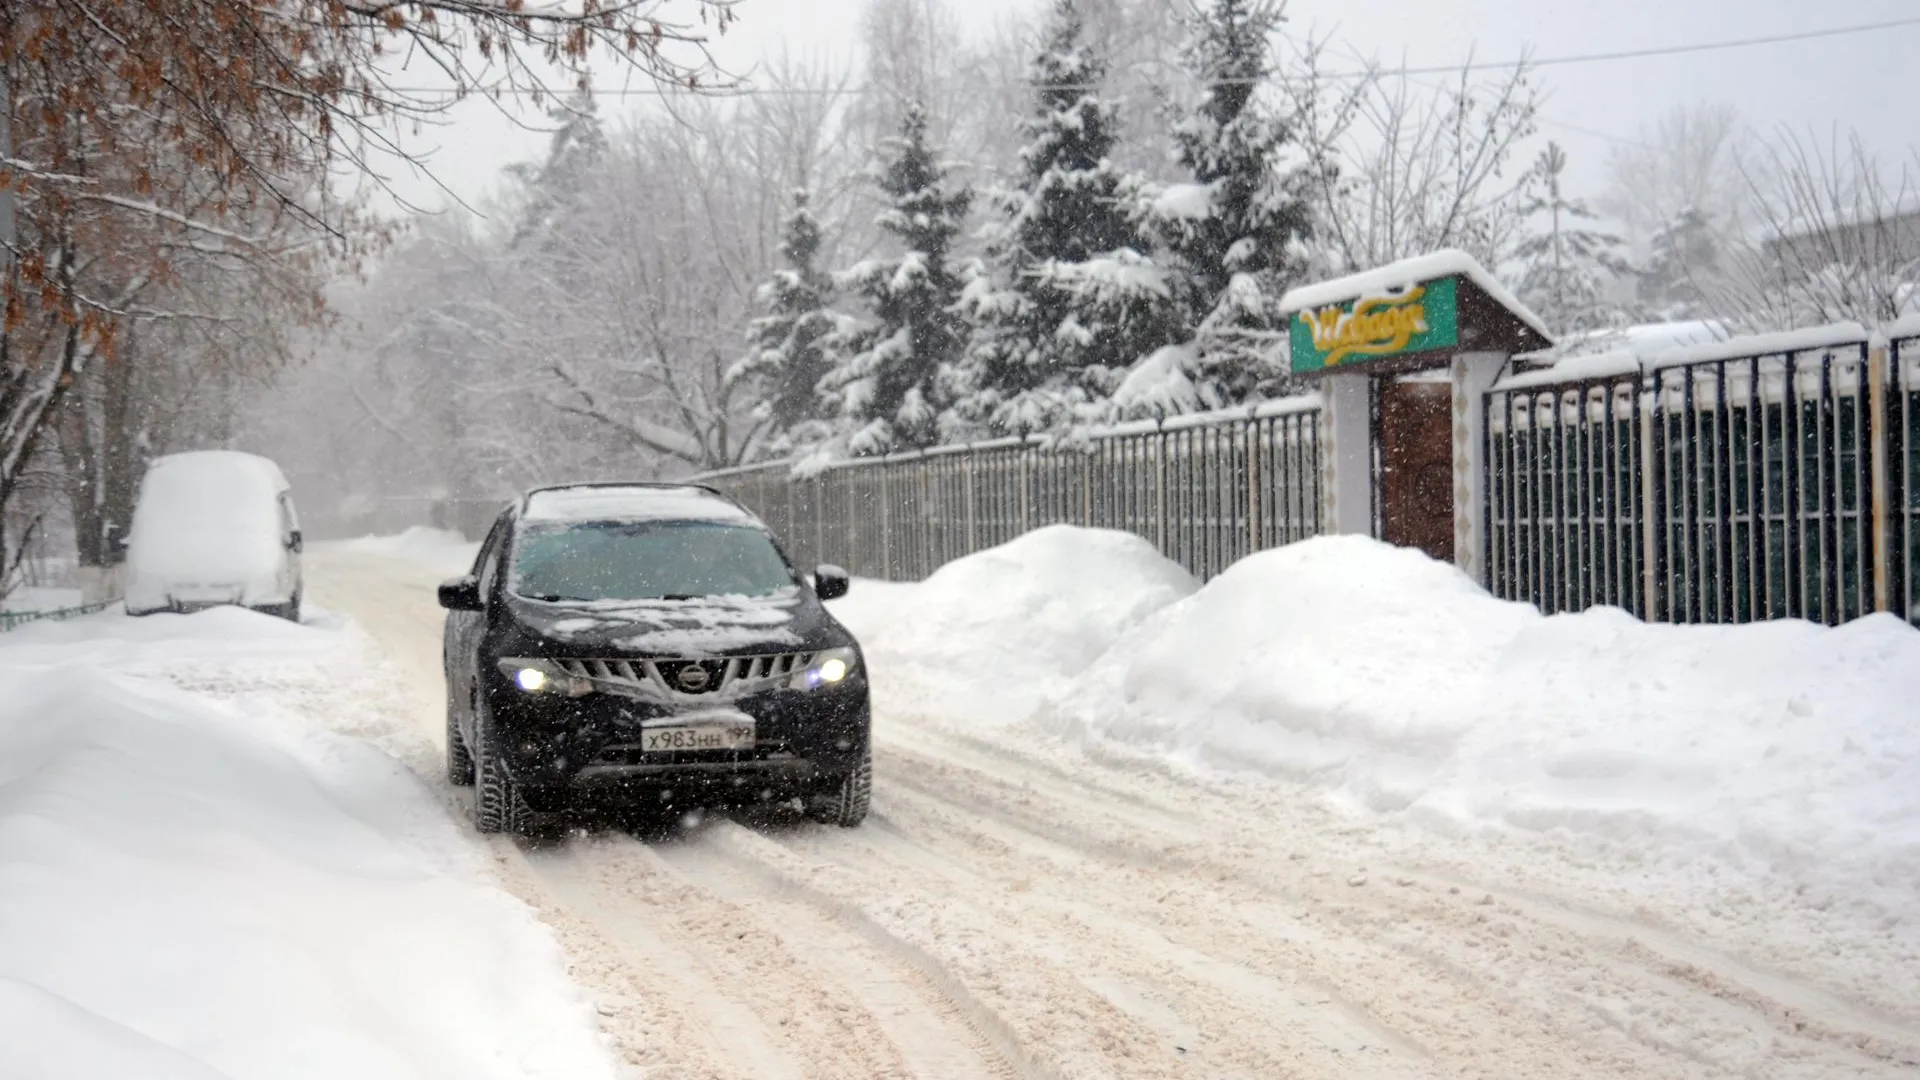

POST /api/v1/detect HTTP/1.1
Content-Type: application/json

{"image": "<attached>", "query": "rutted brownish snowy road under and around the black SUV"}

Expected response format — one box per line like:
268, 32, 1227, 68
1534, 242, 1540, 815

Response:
307, 548, 1920, 1080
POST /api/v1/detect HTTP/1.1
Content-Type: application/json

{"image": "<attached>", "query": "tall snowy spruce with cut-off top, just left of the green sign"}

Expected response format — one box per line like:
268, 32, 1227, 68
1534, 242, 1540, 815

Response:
1146, 0, 1311, 405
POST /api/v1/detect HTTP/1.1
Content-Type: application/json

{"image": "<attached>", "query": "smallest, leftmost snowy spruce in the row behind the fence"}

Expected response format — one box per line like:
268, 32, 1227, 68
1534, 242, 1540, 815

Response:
733, 188, 841, 455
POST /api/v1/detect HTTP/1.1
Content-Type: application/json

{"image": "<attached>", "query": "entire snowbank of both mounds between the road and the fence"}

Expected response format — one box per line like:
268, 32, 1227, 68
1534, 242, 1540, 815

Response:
839, 527, 1920, 891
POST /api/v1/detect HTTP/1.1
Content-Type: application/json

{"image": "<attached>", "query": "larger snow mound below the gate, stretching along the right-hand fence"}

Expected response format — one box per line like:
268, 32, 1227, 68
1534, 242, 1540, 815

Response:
1039, 536, 1920, 892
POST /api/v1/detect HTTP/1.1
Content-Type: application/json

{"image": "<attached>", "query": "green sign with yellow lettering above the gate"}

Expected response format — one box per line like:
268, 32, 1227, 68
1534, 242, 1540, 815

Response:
1290, 277, 1459, 373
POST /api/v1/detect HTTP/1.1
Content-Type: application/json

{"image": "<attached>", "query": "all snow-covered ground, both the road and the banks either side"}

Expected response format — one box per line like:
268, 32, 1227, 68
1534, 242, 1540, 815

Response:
11, 528, 1920, 1080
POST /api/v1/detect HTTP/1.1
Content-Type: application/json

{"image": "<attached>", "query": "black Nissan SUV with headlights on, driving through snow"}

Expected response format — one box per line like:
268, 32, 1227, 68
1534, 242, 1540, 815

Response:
440, 484, 872, 836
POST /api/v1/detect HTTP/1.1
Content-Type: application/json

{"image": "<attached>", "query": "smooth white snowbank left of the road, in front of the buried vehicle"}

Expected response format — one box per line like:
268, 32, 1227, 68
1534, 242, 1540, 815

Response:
0, 607, 614, 1080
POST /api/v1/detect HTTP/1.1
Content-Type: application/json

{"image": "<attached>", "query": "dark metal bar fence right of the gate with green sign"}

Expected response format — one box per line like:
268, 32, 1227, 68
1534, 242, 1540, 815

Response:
1484, 331, 1896, 625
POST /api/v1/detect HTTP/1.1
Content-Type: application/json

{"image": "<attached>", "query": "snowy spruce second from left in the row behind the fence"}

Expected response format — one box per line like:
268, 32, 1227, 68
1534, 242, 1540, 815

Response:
826, 102, 973, 455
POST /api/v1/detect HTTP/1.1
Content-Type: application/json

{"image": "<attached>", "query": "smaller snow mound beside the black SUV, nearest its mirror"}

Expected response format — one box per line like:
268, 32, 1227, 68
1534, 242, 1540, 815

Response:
829, 525, 1196, 723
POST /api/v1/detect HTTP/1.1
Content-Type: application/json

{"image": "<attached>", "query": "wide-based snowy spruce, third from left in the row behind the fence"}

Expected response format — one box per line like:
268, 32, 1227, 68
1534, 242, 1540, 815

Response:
954, 0, 1179, 436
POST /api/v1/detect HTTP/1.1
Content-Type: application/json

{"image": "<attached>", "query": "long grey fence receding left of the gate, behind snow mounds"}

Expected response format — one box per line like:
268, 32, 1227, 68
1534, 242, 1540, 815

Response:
701, 396, 1321, 580
